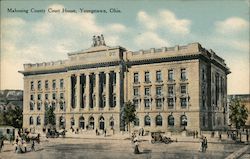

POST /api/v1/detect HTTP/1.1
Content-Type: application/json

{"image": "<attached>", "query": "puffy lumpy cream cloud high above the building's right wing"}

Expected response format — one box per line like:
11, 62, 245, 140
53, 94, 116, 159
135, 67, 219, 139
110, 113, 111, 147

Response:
137, 10, 191, 35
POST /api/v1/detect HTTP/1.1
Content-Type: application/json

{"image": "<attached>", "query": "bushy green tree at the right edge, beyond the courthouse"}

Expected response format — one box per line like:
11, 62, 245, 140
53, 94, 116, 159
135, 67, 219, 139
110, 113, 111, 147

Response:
229, 99, 248, 129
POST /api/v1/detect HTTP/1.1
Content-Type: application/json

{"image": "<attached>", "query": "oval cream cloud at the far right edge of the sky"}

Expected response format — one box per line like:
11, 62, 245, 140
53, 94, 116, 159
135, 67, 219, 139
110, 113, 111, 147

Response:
215, 17, 249, 34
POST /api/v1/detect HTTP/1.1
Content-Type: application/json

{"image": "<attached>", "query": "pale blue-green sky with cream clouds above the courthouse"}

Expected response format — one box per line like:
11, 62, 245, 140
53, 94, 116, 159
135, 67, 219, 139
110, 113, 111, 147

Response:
0, 0, 250, 94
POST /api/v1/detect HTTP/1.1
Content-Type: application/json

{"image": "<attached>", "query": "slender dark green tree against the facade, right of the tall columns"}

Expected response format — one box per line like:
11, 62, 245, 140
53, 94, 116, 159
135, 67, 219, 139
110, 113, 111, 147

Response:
123, 101, 136, 134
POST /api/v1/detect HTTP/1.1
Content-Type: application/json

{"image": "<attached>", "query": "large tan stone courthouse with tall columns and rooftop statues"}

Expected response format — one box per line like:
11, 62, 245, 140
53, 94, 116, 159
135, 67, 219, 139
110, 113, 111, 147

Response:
20, 35, 230, 132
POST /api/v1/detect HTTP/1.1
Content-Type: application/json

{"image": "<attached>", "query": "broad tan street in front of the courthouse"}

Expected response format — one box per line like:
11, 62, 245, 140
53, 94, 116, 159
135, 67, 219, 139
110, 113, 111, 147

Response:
0, 138, 248, 159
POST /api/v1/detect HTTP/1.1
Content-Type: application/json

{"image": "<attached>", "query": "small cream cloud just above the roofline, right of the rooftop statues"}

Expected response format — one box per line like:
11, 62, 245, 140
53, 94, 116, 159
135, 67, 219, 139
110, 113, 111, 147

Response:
134, 32, 169, 48
